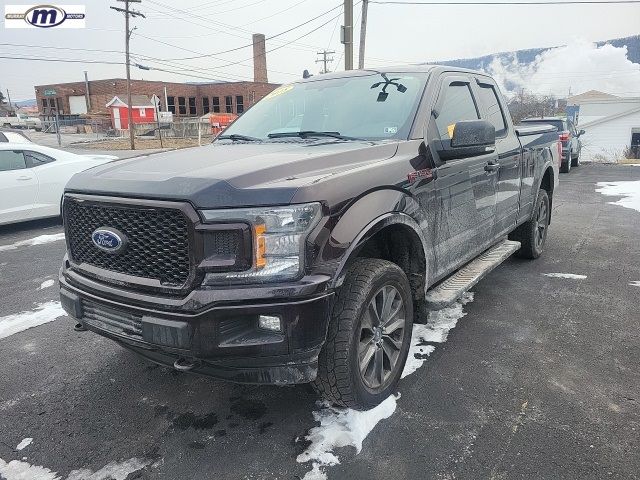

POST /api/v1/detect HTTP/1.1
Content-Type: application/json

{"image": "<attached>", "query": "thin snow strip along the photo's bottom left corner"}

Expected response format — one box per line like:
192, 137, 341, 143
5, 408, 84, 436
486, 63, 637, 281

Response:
0, 458, 151, 480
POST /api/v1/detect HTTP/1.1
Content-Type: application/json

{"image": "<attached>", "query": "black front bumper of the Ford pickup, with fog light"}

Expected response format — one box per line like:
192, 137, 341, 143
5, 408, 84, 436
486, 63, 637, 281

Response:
60, 272, 333, 384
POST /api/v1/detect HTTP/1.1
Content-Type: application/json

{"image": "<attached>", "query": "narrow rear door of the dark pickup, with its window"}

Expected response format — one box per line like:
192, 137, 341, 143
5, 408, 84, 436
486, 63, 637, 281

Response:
474, 76, 522, 238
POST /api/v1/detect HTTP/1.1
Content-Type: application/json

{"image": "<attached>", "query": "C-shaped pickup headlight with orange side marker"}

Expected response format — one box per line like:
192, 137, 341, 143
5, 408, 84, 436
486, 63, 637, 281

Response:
200, 203, 322, 285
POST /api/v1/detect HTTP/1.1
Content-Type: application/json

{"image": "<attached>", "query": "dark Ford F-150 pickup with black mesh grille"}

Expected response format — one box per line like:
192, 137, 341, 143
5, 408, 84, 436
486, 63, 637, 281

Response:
59, 66, 560, 408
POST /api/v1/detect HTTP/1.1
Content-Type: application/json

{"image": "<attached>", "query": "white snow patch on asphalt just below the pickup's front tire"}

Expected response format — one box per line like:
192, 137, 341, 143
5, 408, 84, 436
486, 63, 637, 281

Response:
297, 395, 397, 480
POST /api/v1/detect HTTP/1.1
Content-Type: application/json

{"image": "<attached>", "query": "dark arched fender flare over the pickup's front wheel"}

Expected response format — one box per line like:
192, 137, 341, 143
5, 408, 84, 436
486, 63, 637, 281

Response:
330, 212, 430, 293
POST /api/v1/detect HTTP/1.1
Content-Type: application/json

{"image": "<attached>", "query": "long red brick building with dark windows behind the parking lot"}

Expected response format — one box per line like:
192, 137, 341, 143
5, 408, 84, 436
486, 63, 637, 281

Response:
35, 78, 278, 117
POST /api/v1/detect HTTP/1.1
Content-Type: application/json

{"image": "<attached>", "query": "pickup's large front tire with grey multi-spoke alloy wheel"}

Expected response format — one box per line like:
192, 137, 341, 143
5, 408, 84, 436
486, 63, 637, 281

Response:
312, 258, 413, 410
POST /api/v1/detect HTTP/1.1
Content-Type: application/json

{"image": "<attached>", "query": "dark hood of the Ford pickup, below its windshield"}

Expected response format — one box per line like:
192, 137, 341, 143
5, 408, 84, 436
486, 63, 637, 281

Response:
66, 140, 397, 208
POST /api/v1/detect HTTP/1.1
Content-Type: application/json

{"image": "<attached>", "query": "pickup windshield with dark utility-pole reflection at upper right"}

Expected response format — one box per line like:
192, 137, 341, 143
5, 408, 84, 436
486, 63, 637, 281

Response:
224, 73, 426, 140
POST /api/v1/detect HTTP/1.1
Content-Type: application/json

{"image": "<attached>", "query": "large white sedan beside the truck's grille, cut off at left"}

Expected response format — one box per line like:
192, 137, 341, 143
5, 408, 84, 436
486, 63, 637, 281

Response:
0, 143, 118, 225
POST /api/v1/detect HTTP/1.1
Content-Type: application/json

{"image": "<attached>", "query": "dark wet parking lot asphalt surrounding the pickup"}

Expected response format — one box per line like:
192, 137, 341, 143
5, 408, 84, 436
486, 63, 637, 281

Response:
0, 165, 640, 480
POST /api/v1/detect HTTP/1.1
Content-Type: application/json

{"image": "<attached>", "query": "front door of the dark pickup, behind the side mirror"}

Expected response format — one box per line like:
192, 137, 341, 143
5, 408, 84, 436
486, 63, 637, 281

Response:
427, 74, 497, 276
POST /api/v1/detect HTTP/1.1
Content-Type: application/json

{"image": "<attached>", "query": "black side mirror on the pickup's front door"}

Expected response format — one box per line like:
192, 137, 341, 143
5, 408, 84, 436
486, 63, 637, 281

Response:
438, 120, 496, 160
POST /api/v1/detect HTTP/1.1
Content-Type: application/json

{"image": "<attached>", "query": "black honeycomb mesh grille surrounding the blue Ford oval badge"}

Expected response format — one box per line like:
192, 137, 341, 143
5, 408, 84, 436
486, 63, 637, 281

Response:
64, 197, 195, 288
